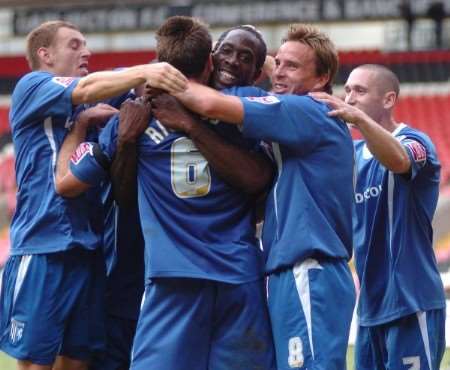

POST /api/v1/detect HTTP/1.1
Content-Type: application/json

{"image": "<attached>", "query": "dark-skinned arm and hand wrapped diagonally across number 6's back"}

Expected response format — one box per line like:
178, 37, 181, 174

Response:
152, 94, 274, 195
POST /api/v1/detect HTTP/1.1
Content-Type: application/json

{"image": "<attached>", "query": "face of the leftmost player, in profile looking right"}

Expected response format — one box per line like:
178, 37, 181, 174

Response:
43, 27, 91, 77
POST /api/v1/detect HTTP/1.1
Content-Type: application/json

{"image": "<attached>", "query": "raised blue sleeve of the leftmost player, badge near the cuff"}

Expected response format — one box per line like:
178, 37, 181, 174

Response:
11, 72, 79, 128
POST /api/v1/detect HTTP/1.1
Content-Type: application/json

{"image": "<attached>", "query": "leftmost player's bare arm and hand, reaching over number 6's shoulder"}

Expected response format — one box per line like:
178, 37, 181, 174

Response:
72, 63, 187, 105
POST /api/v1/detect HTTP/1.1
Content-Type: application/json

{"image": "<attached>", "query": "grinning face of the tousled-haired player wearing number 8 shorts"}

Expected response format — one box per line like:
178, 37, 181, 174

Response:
272, 41, 329, 95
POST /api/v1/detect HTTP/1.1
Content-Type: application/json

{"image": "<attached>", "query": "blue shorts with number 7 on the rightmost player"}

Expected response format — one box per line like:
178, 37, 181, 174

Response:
355, 309, 445, 370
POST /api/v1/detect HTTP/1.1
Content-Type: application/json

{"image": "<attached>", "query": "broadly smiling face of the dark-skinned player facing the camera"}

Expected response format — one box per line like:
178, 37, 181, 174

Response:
211, 29, 261, 89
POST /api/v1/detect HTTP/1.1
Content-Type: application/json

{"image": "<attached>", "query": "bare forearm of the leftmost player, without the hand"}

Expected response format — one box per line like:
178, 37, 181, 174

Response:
72, 66, 146, 105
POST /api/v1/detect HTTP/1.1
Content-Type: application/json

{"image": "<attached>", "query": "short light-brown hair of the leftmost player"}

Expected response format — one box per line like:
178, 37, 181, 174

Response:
26, 20, 80, 71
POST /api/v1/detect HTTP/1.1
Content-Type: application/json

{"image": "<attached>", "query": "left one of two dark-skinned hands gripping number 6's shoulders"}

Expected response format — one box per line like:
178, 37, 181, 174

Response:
118, 97, 152, 143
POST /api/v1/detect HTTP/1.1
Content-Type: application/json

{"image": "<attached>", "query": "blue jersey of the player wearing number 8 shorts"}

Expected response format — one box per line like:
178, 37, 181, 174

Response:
241, 95, 354, 273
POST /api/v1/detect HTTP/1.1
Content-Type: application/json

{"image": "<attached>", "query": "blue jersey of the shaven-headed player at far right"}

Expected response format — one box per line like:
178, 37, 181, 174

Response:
355, 124, 445, 326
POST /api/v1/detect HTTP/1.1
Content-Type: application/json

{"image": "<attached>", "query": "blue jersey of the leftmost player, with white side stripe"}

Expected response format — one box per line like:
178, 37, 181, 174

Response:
10, 72, 101, 255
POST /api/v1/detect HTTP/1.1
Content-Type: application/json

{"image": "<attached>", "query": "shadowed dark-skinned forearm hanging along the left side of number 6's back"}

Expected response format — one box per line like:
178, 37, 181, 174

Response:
111, 141, 137, 207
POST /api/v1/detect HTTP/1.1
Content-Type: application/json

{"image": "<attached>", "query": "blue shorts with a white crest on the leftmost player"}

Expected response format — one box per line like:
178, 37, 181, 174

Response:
0, 249, 105, 365
